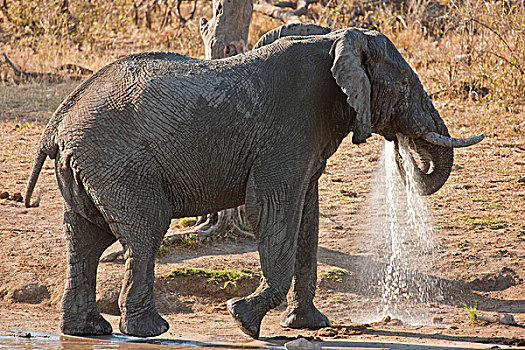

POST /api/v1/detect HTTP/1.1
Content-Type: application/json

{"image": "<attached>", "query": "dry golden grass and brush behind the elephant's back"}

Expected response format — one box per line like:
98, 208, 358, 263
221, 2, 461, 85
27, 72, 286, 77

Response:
0, 0, 525, 105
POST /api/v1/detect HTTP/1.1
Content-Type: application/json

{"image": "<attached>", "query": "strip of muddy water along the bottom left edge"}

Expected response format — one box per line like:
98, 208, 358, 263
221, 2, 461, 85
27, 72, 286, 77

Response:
0, 330, 271, 350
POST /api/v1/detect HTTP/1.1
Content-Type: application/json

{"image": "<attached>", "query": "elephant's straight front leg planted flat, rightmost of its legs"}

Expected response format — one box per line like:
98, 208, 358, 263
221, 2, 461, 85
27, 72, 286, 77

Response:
281, 180, 330, 328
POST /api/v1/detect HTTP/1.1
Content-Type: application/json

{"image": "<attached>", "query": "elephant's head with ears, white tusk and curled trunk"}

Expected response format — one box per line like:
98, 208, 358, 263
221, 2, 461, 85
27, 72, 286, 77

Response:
255, 24, 485, 195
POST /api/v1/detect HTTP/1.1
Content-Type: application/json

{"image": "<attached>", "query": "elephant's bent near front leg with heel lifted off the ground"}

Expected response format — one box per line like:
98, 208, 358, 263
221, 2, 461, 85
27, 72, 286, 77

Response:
227, 171, 306, 338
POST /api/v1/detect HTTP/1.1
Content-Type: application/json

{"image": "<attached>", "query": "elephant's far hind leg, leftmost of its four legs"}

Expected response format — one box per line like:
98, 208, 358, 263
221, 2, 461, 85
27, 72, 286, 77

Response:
61, 204, 116, 335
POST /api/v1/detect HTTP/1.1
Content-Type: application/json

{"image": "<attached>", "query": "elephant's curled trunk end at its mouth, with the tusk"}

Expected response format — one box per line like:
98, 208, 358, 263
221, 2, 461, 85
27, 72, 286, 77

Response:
394, 131, 485, 196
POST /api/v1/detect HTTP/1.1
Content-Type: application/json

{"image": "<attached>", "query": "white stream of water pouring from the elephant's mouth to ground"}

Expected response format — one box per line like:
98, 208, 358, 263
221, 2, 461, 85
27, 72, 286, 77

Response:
364, 137, 442, 324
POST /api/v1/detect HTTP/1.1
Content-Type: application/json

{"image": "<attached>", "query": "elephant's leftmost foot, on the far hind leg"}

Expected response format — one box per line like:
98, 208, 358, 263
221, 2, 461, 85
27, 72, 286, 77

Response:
61, 312, 113, 335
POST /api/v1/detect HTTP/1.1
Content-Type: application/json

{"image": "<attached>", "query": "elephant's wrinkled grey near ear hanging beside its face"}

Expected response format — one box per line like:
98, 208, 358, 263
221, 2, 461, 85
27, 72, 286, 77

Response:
330, 29, 372, 144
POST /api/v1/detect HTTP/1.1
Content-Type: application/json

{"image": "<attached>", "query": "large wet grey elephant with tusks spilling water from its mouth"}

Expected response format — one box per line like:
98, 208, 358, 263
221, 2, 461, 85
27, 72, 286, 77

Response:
25, 24, 484, 338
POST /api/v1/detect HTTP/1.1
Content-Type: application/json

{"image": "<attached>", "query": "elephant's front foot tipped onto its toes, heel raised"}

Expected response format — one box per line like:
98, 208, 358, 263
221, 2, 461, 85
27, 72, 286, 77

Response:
227, 298, 266, 339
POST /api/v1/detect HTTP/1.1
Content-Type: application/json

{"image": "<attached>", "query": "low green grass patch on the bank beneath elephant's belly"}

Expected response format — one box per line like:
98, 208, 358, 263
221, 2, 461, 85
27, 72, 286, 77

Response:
164, 267, 253, 288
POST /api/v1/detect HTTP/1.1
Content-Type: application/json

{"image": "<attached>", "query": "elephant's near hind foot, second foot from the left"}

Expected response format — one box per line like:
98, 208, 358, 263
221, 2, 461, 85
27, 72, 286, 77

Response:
119, 310, 170, 337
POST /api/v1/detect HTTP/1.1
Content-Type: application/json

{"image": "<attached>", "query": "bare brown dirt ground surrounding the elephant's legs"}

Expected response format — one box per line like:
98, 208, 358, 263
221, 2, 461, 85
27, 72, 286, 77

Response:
0, 78, 525, 347
